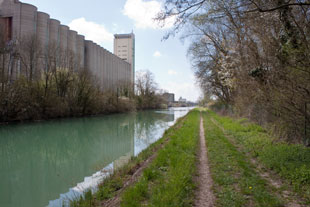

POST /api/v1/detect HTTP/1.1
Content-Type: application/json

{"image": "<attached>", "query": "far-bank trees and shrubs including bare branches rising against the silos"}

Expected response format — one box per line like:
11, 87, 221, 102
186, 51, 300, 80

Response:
0, 30, 163, 122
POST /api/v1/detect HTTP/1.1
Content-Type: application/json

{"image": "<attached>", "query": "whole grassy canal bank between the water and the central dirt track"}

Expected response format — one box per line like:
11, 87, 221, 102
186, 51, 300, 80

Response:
70, 110, 200, 207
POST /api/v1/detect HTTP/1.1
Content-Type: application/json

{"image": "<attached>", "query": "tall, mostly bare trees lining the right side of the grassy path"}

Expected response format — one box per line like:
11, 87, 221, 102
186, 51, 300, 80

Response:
157, 0, 310, 145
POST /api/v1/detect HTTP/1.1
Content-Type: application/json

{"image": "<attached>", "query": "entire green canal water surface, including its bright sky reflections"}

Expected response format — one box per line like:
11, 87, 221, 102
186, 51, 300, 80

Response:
0, 108, 193, 207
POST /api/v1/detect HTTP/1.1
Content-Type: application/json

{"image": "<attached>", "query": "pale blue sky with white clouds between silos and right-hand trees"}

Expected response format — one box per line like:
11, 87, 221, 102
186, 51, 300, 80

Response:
21, 0, 200, 101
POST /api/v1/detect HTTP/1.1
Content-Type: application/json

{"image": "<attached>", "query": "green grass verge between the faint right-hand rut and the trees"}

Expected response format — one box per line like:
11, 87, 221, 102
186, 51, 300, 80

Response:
212, 112, 310, 204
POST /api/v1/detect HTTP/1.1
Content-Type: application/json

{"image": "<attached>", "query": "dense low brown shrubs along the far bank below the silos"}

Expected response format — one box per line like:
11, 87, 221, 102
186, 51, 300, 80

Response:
0, 66, 165, 122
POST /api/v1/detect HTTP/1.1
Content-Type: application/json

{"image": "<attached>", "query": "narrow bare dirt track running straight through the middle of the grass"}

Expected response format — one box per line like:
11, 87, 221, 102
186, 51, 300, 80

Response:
195, 116, 215, 207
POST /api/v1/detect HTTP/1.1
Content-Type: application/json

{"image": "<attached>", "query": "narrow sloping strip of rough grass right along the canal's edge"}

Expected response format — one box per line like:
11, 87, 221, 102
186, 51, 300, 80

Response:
70, 113, 186, 207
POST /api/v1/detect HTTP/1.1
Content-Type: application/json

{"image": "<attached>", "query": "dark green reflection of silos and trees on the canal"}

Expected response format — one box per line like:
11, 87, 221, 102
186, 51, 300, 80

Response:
0, 114, 134, 206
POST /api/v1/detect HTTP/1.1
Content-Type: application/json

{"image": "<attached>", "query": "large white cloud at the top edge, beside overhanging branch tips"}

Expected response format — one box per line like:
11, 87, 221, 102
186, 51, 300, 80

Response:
123, 0, 175, 29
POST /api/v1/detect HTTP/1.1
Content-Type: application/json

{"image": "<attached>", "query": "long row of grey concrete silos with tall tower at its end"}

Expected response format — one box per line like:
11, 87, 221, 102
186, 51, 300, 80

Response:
0, 0, 135, 90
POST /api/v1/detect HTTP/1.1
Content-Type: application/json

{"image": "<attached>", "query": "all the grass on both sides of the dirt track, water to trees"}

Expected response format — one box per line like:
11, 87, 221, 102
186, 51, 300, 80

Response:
72, 109, 310, 207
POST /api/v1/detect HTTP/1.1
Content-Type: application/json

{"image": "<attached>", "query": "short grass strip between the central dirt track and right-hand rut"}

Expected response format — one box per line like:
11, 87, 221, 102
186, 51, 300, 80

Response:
203, 112, 282, 207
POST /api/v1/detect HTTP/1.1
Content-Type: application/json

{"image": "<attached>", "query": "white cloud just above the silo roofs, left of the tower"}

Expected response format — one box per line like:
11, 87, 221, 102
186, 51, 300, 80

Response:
69, 17, 114, 45
